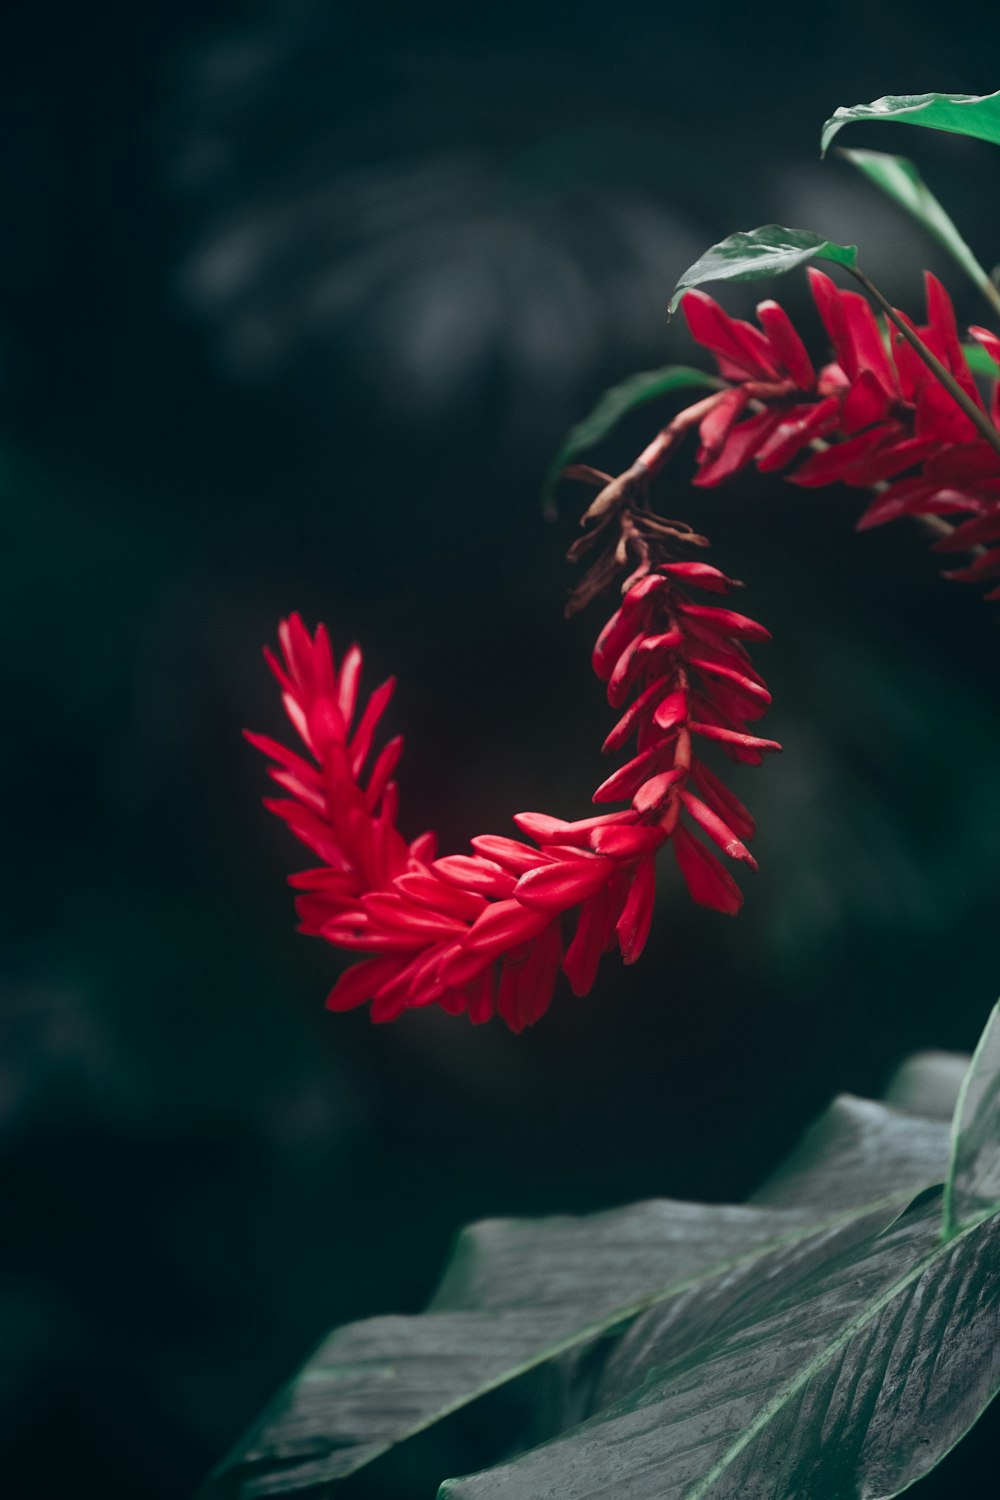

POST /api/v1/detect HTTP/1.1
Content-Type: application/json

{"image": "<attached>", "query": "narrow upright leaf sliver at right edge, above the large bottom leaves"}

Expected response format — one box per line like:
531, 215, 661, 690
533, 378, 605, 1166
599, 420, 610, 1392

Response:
943, 1005, 1000, 1239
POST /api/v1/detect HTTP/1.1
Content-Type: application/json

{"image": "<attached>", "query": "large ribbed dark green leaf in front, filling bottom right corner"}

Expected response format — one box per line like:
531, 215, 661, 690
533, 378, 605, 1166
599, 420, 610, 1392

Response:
439, 1193, 1000, 1500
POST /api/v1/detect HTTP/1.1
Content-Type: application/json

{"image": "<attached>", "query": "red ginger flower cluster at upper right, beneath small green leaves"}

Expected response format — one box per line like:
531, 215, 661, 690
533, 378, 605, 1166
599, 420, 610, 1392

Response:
659, 269, 1000, 599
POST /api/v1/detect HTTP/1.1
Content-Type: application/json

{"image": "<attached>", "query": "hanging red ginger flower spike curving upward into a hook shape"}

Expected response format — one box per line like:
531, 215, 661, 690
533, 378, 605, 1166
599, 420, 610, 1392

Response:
247, 557, 778, 1031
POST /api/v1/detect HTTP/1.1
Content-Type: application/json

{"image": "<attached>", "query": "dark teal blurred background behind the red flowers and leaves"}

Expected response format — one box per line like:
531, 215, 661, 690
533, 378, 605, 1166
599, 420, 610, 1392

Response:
0, 0, 1000, 1500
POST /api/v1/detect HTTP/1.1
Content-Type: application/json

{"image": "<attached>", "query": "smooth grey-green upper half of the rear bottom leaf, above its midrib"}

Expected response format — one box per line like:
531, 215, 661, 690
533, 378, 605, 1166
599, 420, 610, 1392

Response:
205, 1193, 907, 1500
